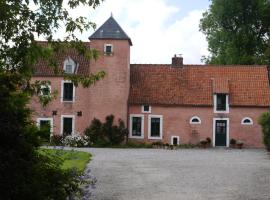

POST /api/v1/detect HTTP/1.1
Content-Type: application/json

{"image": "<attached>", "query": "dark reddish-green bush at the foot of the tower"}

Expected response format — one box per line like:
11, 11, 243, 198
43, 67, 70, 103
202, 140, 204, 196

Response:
84, 115, 128, 146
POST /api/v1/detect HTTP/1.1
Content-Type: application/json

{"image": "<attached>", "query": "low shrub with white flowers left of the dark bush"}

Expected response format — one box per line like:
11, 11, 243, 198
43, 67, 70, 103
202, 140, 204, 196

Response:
63, 134, 89, 147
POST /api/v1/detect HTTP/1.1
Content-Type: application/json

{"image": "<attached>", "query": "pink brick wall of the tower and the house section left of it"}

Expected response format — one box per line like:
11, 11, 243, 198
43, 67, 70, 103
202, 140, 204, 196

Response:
30, 40, 130, 134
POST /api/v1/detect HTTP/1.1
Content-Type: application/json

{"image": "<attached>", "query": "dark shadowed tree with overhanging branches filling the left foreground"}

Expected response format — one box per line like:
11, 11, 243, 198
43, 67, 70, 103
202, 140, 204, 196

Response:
0, 0, 105, 199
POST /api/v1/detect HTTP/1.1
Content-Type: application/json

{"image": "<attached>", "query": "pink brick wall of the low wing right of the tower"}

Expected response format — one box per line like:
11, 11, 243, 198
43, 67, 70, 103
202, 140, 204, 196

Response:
129, 105, 267, 147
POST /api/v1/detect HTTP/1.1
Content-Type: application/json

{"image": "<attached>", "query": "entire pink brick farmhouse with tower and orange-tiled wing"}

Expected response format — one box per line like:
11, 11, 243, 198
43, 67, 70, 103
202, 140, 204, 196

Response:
31, 17, 270, 147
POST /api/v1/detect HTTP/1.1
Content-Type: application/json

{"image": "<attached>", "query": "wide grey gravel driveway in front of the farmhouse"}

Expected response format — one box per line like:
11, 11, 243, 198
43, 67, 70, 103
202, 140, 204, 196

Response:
81, 149, 270, 200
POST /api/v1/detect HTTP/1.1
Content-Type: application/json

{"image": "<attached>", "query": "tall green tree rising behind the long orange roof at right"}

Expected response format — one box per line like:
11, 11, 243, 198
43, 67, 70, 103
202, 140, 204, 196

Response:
200, 0, 270, 65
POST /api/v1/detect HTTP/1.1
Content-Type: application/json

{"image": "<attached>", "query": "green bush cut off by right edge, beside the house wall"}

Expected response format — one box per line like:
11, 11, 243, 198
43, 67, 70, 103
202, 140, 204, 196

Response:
258, 112, 270, 151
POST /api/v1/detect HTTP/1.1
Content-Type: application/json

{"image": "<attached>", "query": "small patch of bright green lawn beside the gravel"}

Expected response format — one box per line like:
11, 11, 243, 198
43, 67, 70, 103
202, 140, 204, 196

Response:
39, 149, 92, 171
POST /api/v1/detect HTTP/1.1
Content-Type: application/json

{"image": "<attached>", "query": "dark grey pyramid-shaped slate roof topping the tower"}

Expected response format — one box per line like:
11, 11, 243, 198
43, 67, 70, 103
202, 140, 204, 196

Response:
89, 16, 132, 45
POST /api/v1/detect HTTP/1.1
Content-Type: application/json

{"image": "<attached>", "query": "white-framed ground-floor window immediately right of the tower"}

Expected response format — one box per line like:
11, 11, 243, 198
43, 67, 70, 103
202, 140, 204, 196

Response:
130, 114, 144, 138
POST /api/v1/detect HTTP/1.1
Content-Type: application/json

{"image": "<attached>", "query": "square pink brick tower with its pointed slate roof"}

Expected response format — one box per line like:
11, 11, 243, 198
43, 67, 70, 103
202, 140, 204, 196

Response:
89, 16, 132, 125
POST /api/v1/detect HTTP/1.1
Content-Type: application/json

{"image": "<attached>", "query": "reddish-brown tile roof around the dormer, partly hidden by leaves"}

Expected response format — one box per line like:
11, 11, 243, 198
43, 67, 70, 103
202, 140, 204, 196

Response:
34, 41, 90, 76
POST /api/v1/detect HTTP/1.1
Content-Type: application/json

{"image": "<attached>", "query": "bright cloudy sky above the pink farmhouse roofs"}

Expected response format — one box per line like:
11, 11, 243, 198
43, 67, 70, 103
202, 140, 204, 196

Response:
53, 0, 209, 64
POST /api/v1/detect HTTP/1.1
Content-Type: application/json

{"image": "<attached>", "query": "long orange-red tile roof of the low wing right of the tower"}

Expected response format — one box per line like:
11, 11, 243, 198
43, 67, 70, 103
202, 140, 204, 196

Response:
129, 64, 270, 106
